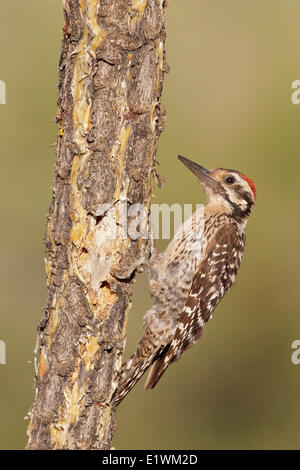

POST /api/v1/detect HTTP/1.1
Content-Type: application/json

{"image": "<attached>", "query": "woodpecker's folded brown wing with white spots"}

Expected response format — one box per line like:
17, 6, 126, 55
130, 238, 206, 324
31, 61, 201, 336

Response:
145, 224, 245, 389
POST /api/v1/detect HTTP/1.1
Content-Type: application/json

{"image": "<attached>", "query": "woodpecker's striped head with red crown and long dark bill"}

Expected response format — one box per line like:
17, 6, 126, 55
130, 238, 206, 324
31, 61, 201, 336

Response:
178, 155, 256, 219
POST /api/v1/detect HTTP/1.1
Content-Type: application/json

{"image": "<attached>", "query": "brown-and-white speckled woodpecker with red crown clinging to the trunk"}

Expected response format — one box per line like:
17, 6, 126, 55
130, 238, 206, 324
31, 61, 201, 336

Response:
114, 155, 256, 405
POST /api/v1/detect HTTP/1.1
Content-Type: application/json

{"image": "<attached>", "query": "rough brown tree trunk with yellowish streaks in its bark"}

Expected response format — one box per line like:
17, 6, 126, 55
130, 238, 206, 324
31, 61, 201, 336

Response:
27, 0, 165, 449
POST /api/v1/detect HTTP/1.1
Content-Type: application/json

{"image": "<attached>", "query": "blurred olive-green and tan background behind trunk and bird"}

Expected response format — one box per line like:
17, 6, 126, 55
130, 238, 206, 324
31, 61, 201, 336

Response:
0, 0, 300, 449
